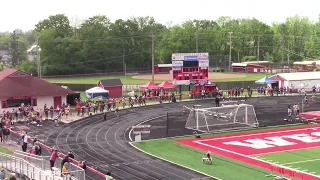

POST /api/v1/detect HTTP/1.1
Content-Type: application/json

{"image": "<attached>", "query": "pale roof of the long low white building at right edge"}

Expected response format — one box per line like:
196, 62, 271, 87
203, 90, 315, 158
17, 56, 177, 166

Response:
272, 71, 320, 81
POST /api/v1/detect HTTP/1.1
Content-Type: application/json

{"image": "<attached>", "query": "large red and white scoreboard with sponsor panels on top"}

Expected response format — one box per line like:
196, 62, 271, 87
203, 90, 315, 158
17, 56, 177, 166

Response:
172, 53, 209, 85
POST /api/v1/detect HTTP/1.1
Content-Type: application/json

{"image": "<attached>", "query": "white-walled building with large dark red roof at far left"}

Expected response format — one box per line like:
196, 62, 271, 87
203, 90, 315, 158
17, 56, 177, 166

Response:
0, 69, 74, 111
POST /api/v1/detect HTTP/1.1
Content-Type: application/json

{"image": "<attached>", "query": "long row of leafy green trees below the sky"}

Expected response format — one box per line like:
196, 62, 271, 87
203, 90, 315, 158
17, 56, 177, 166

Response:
0, 14, 320, 75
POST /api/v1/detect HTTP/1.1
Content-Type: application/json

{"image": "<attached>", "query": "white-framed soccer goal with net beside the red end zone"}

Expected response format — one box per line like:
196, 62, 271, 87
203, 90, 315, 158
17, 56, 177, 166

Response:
185, 104, 259, 132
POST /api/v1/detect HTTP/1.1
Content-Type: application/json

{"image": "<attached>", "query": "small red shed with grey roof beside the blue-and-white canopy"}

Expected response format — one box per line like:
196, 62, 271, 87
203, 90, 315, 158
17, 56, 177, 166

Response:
98, 79, 123, 98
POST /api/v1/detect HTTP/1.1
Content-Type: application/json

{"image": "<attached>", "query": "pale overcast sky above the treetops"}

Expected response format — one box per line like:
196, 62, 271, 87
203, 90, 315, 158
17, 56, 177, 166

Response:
0, 0, 320, 32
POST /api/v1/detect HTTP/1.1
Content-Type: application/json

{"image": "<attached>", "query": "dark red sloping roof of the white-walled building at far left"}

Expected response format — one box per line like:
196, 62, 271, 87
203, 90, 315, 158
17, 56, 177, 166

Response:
0, 69, 74, 98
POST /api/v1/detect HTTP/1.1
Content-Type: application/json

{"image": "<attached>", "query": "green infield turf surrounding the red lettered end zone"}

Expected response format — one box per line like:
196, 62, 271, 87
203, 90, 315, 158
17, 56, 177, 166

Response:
132, 125, 320, 180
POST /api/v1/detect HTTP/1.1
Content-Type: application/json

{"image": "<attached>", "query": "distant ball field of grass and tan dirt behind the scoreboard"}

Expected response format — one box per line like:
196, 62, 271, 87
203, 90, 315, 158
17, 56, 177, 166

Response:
45, 73, 268, 84
